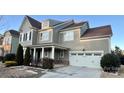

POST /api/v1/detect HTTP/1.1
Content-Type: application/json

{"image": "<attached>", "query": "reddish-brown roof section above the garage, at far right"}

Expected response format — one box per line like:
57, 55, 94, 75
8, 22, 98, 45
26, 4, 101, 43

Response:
81, 25, 112, 38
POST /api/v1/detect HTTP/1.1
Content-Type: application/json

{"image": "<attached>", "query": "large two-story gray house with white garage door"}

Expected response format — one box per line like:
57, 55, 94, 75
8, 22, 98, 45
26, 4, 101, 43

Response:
19, 16, 112, 68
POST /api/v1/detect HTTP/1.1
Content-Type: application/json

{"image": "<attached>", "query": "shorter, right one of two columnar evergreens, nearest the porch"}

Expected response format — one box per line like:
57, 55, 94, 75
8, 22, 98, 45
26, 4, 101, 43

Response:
24, 47, 31, 66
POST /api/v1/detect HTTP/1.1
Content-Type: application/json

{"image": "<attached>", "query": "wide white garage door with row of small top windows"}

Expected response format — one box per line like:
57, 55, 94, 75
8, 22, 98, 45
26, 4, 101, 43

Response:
69, 51, 103, 68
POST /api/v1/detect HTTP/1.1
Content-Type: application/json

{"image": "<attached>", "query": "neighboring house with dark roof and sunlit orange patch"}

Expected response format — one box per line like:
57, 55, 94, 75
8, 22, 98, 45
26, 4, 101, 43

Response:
3, 30, 19, 55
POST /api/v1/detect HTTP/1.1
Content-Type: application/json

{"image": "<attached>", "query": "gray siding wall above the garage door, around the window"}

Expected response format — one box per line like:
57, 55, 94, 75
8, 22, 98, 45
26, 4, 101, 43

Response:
59, 29, 110, 53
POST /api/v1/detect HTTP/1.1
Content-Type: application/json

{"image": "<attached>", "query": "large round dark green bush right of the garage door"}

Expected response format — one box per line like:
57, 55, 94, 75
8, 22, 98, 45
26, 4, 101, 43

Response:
101, 54, 121, 72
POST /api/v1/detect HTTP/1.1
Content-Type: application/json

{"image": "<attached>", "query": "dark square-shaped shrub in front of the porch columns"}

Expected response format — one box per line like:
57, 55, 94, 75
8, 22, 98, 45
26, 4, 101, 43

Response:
42, 58, 54, 69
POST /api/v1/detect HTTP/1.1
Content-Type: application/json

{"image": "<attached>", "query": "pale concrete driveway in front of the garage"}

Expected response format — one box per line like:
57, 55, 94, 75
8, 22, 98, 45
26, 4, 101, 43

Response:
41, 66, 101, 78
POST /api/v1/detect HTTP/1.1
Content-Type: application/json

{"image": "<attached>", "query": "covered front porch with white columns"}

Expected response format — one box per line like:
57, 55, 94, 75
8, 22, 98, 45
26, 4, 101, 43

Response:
24, 45, 69, 65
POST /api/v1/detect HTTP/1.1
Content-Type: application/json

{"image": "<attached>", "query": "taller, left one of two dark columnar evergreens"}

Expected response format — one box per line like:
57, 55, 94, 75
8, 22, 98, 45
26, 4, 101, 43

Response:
16, 44, 23, 65
